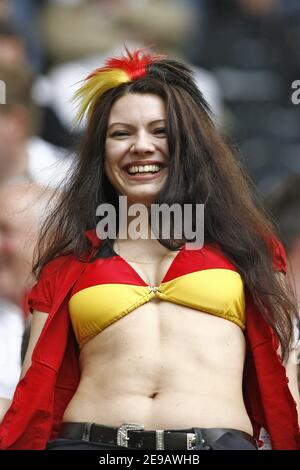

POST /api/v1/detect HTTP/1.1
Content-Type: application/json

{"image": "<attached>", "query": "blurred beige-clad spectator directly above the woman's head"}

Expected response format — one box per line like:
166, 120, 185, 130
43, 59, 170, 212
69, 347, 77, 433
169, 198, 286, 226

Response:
41, 0, 197, 63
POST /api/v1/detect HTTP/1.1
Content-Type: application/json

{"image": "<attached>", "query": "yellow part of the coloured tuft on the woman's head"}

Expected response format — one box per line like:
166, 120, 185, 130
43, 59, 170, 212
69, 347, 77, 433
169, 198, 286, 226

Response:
73, 69, 131, 124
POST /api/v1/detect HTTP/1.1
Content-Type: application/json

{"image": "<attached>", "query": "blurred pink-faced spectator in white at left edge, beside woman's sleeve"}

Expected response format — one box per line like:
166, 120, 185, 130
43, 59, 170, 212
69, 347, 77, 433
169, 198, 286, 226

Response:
0, 183, 52, 398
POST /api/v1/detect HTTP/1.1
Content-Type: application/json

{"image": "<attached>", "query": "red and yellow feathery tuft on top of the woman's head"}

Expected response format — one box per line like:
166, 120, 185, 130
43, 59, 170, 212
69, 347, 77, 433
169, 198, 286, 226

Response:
74, 47, 165, 123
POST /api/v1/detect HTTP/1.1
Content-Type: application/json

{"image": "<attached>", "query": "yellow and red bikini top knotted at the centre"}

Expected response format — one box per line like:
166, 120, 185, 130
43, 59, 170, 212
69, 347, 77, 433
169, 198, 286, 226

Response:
69, 241, 245, 348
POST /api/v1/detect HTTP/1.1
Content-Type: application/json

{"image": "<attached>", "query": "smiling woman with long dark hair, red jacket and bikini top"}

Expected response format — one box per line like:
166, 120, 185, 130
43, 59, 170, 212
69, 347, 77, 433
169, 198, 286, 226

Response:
0, 51, 299, 450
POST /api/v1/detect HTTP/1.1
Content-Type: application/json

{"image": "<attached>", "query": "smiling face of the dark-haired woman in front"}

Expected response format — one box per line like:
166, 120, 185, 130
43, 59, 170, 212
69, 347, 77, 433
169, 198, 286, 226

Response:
105, 93, 169, 205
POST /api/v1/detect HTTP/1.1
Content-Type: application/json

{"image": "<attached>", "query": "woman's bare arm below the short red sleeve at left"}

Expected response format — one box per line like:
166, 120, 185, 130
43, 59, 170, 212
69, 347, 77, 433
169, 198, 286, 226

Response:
0, 311, 48, 423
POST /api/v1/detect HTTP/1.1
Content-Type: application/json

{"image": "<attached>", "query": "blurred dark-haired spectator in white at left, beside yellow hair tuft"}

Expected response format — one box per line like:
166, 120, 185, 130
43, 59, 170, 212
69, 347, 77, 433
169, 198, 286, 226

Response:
0, 65, 71, 187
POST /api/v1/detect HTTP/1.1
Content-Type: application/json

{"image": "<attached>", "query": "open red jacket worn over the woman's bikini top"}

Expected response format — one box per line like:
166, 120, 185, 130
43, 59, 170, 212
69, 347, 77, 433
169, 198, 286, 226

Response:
0, 236, 300, 450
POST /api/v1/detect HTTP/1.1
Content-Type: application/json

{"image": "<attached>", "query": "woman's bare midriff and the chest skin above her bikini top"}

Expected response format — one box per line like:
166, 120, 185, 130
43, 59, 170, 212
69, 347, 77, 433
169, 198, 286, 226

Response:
63, 244, 253, 434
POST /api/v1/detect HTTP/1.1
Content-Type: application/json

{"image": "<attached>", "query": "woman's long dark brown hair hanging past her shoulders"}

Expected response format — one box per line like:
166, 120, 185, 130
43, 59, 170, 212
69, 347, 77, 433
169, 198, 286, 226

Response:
34, 60, 296, 358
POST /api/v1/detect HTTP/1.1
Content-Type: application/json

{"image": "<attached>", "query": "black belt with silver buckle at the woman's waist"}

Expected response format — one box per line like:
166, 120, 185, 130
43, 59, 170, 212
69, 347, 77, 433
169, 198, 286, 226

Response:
59, 422, 256, 450
